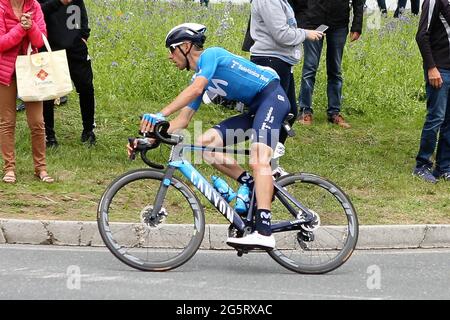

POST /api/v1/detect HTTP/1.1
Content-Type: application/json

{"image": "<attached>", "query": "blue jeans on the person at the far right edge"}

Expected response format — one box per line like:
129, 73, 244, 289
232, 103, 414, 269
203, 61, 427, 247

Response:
416, 69, 450, 174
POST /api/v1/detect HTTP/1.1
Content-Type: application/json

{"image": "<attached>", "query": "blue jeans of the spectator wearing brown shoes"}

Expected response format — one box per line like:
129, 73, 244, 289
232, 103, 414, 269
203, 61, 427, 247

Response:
299, 27, 348, 117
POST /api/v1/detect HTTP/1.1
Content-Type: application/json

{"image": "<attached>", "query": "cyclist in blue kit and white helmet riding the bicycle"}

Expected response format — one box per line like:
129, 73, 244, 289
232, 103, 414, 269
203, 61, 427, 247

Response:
134, 23, 320, 249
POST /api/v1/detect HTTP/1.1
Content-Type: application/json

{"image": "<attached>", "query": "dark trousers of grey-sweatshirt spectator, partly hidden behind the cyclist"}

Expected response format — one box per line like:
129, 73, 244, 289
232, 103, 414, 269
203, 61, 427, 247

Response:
250, 56, 298, 144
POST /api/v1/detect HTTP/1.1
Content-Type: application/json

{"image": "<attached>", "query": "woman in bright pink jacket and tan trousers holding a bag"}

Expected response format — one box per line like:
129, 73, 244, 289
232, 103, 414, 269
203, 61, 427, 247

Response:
0, 0, 53, 183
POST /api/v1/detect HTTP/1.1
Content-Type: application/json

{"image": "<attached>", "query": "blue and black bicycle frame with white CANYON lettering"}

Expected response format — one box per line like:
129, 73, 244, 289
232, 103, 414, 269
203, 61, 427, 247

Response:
149, 144, 314, 232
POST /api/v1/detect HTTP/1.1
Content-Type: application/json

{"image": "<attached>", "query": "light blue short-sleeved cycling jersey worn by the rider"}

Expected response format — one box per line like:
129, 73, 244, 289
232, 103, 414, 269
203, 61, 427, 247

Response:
189, 47, 279, 110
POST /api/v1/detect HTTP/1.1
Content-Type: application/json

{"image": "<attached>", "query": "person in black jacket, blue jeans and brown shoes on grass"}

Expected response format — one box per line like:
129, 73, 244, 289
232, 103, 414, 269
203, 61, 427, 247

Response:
299, 0, 364, 128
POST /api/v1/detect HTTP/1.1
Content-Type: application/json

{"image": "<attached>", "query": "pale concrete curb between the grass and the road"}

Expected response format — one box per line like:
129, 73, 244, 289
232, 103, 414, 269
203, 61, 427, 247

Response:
0, 219, 450, 250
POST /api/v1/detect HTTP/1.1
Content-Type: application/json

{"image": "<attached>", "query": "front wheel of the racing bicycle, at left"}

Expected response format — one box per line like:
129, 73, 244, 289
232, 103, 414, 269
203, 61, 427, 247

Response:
97, 169, 205, 271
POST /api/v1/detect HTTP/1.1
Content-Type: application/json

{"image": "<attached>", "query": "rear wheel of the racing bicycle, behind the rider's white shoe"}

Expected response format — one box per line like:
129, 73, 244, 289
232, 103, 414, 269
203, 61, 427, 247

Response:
268, 173, 359, 274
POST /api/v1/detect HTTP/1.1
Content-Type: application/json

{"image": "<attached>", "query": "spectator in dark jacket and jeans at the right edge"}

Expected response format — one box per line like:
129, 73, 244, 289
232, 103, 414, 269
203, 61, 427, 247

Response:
413, 0, 450, 183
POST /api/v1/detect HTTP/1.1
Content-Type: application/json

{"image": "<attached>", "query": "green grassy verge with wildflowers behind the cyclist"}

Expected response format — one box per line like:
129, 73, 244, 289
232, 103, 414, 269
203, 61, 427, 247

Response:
0, 0, 450, 224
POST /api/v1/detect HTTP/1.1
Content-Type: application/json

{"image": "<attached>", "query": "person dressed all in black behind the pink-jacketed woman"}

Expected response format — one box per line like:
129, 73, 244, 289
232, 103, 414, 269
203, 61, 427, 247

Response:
38, 0, 96, 147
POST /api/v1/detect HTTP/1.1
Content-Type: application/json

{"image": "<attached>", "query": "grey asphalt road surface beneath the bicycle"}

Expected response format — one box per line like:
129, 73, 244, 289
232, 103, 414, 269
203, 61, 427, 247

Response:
0, 245, 450, 300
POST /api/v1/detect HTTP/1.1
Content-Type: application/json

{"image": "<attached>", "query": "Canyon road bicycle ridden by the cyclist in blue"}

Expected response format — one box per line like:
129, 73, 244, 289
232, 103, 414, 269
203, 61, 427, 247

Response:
97, 121, 359, 274
